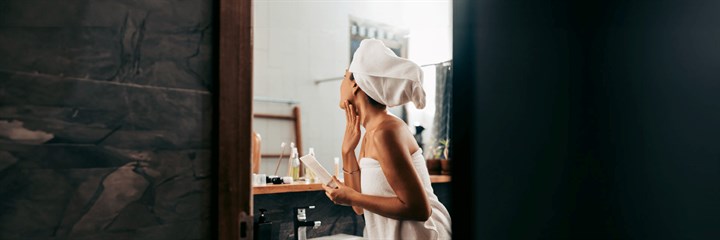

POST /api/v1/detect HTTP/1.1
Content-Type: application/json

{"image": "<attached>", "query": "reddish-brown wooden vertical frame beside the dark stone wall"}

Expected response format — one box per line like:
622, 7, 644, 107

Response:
217, 0, 253, 240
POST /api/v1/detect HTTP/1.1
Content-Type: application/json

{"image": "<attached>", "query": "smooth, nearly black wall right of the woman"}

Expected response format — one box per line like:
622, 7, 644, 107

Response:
452, 0, 720, 239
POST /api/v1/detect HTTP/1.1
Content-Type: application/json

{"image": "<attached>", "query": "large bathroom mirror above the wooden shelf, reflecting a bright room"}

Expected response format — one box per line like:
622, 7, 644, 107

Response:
252, 0, 452, 176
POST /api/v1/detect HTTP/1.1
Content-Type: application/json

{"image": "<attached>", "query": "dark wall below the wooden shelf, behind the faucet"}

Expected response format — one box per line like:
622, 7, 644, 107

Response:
254, 183, 451, 240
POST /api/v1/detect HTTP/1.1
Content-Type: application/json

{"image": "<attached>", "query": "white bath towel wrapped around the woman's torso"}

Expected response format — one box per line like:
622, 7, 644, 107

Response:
359, 150, 451, 240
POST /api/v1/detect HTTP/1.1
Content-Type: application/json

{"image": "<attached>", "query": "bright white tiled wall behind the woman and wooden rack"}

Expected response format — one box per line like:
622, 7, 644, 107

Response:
253, 0, 452, 175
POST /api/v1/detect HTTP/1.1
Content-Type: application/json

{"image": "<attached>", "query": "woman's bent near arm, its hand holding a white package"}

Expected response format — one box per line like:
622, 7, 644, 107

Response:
325, 127, 431, 221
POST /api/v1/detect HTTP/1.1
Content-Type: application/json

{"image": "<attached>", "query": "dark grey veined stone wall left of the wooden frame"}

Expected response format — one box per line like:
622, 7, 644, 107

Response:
0, 0, 214, 239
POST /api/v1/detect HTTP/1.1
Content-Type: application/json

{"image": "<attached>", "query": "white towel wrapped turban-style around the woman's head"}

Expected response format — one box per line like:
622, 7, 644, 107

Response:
349, 39, 425, 109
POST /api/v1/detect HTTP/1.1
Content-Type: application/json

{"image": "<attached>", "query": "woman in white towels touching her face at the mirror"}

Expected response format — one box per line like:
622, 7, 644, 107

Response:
324, 39, 451, 239
